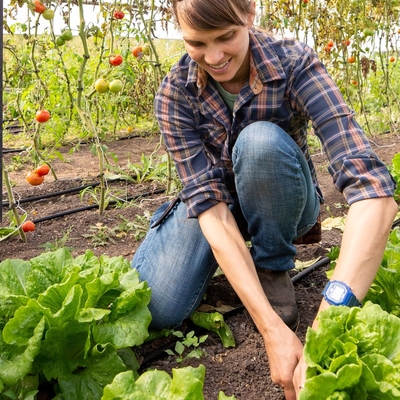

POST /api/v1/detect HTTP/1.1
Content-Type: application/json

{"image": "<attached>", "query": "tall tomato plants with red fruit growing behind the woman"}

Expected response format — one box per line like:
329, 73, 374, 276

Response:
2, 0, 400, 236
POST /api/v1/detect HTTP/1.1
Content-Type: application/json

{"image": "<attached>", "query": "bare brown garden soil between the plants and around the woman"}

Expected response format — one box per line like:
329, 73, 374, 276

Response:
0, 130, 400, 400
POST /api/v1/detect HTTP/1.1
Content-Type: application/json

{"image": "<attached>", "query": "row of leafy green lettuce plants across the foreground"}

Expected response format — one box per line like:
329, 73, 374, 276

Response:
0, 217, 400, 400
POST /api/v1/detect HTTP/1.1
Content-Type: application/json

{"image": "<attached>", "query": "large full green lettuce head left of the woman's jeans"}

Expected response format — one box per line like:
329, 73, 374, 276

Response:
0, 248, 151, 400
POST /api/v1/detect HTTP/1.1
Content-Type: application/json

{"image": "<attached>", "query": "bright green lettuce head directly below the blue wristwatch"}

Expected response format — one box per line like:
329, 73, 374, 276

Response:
299, 302, 400, 400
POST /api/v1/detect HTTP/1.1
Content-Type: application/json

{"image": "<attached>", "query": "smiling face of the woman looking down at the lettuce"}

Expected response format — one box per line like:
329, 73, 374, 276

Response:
179, 10, 253, 84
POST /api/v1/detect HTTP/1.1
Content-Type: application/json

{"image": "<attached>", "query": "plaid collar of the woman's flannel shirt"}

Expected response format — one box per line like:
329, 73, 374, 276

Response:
187, 29, 285, 96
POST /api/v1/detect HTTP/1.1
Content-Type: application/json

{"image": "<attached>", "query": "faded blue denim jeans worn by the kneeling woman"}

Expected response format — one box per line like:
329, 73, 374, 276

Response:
132, 122, 319, 329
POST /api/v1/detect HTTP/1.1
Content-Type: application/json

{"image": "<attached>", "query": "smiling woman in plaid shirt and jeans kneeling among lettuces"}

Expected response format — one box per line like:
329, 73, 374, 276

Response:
132, 0, 397, 400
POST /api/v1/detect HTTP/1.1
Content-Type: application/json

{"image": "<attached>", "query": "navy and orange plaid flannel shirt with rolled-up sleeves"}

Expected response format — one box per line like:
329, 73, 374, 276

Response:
155, 29, 394, 218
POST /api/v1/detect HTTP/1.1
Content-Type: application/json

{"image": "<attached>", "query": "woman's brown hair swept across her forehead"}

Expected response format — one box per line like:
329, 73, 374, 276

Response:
172, 0, 255, 30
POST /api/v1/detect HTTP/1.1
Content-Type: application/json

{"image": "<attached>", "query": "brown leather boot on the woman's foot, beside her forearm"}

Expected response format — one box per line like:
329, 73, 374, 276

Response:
256, 268, 299, 331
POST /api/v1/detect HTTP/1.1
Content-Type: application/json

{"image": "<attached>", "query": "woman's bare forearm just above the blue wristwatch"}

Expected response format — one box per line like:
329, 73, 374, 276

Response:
320, 197, 398, 324
